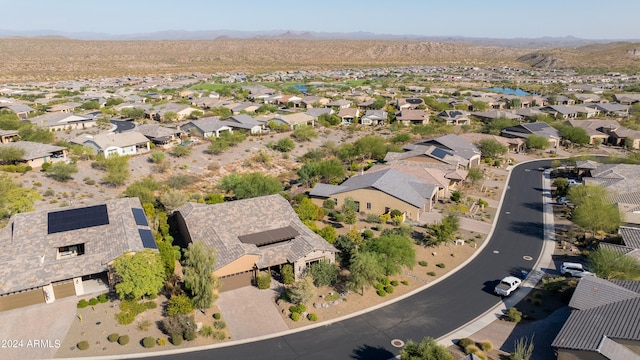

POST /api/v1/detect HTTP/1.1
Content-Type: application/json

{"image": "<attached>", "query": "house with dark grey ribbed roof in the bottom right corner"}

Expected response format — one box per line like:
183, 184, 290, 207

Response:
551, 276, 640, 360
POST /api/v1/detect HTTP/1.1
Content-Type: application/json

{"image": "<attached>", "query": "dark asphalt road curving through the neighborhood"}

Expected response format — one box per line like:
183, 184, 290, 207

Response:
149, 160, 550, 360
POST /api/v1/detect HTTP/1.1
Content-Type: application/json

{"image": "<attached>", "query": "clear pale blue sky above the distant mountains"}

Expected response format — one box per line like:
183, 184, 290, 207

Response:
0, 0, 640, 39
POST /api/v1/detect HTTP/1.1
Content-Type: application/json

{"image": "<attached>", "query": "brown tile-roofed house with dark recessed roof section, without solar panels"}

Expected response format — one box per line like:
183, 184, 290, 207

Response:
172, 195, 338, 291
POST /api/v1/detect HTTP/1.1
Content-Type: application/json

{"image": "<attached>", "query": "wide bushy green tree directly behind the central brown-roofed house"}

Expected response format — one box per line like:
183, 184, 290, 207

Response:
219, 172, 282, 200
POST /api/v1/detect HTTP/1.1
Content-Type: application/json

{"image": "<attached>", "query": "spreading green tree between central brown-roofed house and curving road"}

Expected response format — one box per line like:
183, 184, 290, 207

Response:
362, 234, 416, 276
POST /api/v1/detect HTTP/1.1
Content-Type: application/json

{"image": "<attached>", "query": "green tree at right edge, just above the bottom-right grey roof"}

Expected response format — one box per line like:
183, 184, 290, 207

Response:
588, 247, 640, 280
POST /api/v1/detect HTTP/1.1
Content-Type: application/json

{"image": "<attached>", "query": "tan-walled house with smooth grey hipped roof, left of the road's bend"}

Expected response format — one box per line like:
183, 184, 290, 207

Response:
309, 168, 438, 221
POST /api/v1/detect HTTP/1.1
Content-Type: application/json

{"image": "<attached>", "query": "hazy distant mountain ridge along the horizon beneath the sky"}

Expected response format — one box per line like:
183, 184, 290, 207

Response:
0, 29, 640, 49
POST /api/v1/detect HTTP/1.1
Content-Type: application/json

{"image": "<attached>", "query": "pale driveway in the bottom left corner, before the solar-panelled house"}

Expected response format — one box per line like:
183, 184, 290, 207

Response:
0, 296, 78, 360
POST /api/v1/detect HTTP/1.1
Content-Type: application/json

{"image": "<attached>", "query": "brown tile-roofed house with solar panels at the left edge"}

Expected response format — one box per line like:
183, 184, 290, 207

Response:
0, 198, 157, 311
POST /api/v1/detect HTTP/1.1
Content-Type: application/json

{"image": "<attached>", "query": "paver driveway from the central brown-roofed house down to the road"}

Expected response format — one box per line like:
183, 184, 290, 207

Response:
216, 286, 289, 340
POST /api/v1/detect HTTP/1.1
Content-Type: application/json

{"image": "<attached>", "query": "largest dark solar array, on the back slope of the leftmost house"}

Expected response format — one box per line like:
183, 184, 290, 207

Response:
47, 204, 109, 234
